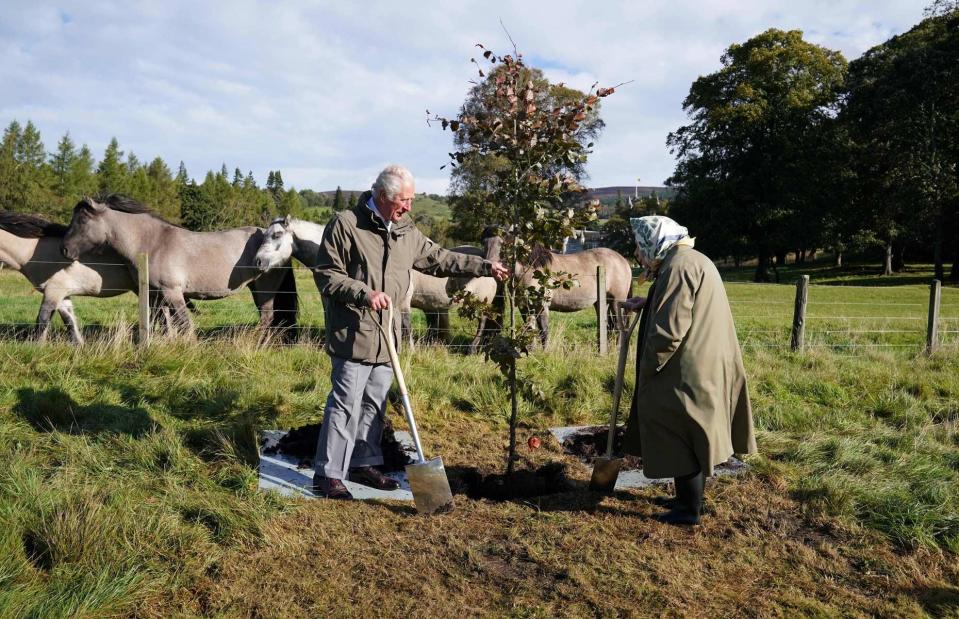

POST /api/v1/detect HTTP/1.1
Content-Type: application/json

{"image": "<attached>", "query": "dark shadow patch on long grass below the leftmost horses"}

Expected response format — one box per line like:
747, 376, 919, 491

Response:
13, 388, 154, 438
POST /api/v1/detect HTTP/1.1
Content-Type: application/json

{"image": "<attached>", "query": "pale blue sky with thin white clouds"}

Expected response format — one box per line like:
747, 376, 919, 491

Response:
0, 0, 931, 193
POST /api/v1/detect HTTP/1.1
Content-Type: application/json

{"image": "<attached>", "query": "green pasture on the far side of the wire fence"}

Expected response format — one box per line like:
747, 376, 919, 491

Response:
0, 267, 959, 354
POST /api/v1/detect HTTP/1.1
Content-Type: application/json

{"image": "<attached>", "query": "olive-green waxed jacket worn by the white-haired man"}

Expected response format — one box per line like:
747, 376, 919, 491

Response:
313, 191, 491, 363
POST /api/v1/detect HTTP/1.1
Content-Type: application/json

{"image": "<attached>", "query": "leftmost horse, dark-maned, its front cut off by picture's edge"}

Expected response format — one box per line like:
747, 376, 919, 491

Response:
0, 211, 136, 344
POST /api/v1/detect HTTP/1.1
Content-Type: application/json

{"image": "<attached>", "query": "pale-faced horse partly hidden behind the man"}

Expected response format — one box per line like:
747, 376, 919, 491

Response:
255, 215, 496, 350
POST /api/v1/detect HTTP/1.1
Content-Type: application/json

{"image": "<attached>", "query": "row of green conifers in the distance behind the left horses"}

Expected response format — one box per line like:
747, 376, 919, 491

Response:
0, 120, 368, 230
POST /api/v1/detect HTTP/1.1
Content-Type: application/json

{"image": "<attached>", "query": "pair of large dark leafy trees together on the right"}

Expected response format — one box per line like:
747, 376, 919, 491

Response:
667, 0, 959, 281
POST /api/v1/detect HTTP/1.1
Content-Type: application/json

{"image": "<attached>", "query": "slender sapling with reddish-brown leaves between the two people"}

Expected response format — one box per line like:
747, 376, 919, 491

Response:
427, 45, 614, 479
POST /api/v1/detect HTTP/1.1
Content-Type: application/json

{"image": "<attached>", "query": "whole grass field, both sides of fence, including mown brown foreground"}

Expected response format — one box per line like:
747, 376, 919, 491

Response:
0, 262, 959, 617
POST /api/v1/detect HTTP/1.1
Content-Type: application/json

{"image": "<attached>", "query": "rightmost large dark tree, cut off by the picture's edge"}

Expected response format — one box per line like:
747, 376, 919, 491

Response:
841, 7, 959, 279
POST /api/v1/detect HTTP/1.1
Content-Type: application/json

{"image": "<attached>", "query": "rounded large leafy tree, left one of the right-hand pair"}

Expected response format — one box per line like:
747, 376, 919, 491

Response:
668, 29, 847, 281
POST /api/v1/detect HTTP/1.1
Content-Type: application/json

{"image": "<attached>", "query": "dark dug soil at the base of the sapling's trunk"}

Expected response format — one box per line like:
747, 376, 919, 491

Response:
446, 462, 573, 501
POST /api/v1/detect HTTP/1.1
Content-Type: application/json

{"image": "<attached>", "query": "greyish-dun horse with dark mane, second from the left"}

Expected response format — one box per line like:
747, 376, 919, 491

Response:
61, 195, 298, 336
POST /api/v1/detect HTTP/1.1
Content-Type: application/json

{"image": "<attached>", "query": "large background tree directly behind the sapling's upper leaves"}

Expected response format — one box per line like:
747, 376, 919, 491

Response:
450, 63, 604, 242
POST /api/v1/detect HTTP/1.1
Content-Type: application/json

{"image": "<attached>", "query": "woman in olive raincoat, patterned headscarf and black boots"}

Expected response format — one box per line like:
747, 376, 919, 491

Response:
624, 216, 756, 524
